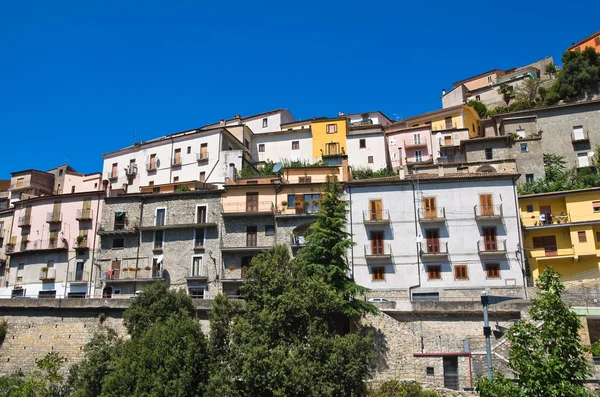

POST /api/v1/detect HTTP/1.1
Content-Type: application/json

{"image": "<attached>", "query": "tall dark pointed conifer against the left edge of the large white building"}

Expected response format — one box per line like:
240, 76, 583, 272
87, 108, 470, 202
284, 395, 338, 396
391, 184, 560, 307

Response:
299, 176, 378, 317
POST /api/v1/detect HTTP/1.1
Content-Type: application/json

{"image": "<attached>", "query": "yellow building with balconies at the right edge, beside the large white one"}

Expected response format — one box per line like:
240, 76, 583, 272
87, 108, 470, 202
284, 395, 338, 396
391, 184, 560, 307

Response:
519, 188, 600, 280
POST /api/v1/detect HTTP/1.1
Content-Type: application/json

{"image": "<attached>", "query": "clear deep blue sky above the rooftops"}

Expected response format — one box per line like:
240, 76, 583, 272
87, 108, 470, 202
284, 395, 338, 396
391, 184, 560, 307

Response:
0, 0, 600, 179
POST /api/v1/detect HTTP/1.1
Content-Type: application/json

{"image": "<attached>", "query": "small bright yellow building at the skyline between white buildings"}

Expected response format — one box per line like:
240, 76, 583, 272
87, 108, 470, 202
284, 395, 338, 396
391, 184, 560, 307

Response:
310, 116, 348, 158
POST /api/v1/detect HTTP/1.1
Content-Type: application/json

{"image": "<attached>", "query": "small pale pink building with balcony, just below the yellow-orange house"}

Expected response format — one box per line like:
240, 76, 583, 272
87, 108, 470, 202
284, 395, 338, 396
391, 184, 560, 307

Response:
386, 123, 434, 171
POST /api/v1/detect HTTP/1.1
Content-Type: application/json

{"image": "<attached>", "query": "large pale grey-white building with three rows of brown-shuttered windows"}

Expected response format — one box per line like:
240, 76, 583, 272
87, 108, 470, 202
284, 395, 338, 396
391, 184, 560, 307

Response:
345, 173, 524, 300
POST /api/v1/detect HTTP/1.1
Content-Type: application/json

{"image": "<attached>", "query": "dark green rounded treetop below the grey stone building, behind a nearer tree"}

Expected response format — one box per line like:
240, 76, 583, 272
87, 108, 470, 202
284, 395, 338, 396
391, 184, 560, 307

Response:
123, 282, 196, 338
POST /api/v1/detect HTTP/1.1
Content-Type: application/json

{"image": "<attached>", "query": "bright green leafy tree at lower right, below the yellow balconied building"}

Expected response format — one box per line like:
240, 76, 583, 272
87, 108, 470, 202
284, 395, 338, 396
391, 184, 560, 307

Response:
477, 267, 591, 397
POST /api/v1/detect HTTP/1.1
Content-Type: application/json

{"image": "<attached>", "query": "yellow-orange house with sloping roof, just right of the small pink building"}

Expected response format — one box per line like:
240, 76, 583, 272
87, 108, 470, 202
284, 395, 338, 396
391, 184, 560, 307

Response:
402, 105, 479, 137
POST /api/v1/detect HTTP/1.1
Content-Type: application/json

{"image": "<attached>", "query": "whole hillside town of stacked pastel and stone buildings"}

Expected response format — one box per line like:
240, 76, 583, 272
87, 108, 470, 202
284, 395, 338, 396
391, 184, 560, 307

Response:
0, 28, 600, 390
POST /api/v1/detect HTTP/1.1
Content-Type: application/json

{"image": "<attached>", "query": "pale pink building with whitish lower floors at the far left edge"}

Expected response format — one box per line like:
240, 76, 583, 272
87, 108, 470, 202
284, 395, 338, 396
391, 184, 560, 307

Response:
0, 189, 104, 298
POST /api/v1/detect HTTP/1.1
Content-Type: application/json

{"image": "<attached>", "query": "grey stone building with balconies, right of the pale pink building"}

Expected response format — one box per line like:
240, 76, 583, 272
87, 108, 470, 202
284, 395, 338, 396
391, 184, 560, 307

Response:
94, 183, 221, 298
